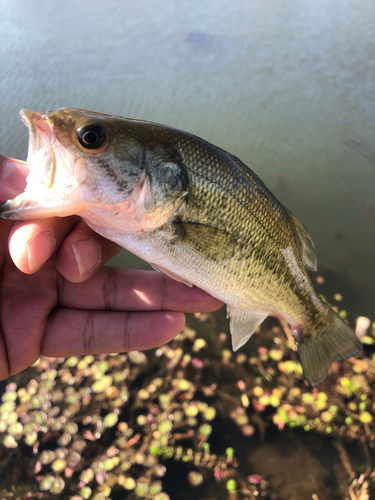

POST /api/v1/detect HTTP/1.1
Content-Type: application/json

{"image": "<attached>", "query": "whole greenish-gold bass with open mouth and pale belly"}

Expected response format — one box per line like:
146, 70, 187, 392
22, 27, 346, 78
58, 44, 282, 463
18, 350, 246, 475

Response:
0, 108, 362, 386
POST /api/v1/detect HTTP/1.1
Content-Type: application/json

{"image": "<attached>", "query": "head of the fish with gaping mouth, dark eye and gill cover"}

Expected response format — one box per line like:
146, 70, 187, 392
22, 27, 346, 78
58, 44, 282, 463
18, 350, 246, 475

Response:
0, 108, 186, 231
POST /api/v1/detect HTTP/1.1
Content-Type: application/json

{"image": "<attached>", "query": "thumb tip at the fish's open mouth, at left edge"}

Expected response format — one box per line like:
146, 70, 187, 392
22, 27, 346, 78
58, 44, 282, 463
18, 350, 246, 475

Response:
0, 155, 30, 201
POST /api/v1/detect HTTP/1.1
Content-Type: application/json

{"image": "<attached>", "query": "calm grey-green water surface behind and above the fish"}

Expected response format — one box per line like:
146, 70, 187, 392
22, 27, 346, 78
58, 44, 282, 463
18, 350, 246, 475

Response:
0, 4, 375, 498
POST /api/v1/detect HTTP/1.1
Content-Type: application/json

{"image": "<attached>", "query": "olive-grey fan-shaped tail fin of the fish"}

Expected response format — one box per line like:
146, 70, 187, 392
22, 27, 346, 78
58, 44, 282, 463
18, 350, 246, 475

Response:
298, 310, 362, 386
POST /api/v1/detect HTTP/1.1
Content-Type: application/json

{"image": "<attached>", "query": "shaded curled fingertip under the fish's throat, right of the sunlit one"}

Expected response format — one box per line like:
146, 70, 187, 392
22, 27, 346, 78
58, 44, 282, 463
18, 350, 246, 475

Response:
56, 221, 121, 283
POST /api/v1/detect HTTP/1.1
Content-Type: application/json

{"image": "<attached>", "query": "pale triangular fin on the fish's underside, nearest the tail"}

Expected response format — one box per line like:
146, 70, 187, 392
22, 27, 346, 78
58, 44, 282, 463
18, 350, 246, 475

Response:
227, 306, 268, 351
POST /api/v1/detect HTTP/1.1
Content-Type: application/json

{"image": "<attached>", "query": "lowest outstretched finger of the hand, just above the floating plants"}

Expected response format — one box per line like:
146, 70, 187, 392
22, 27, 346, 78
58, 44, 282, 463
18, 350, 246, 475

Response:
41, 309, 185, 357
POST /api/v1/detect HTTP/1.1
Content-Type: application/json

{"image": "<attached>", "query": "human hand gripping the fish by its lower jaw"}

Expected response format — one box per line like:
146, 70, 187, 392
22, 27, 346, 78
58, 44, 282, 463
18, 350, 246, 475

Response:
0, 155, 222, 380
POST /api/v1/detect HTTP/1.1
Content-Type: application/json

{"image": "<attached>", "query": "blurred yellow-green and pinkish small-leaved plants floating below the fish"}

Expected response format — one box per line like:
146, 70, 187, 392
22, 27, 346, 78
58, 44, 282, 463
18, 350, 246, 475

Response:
0, 298, 375, 500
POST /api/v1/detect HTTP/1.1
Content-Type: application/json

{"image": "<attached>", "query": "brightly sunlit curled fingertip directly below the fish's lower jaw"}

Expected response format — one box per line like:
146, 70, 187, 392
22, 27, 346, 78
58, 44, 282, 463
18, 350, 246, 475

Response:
9, 216, 80, 274
